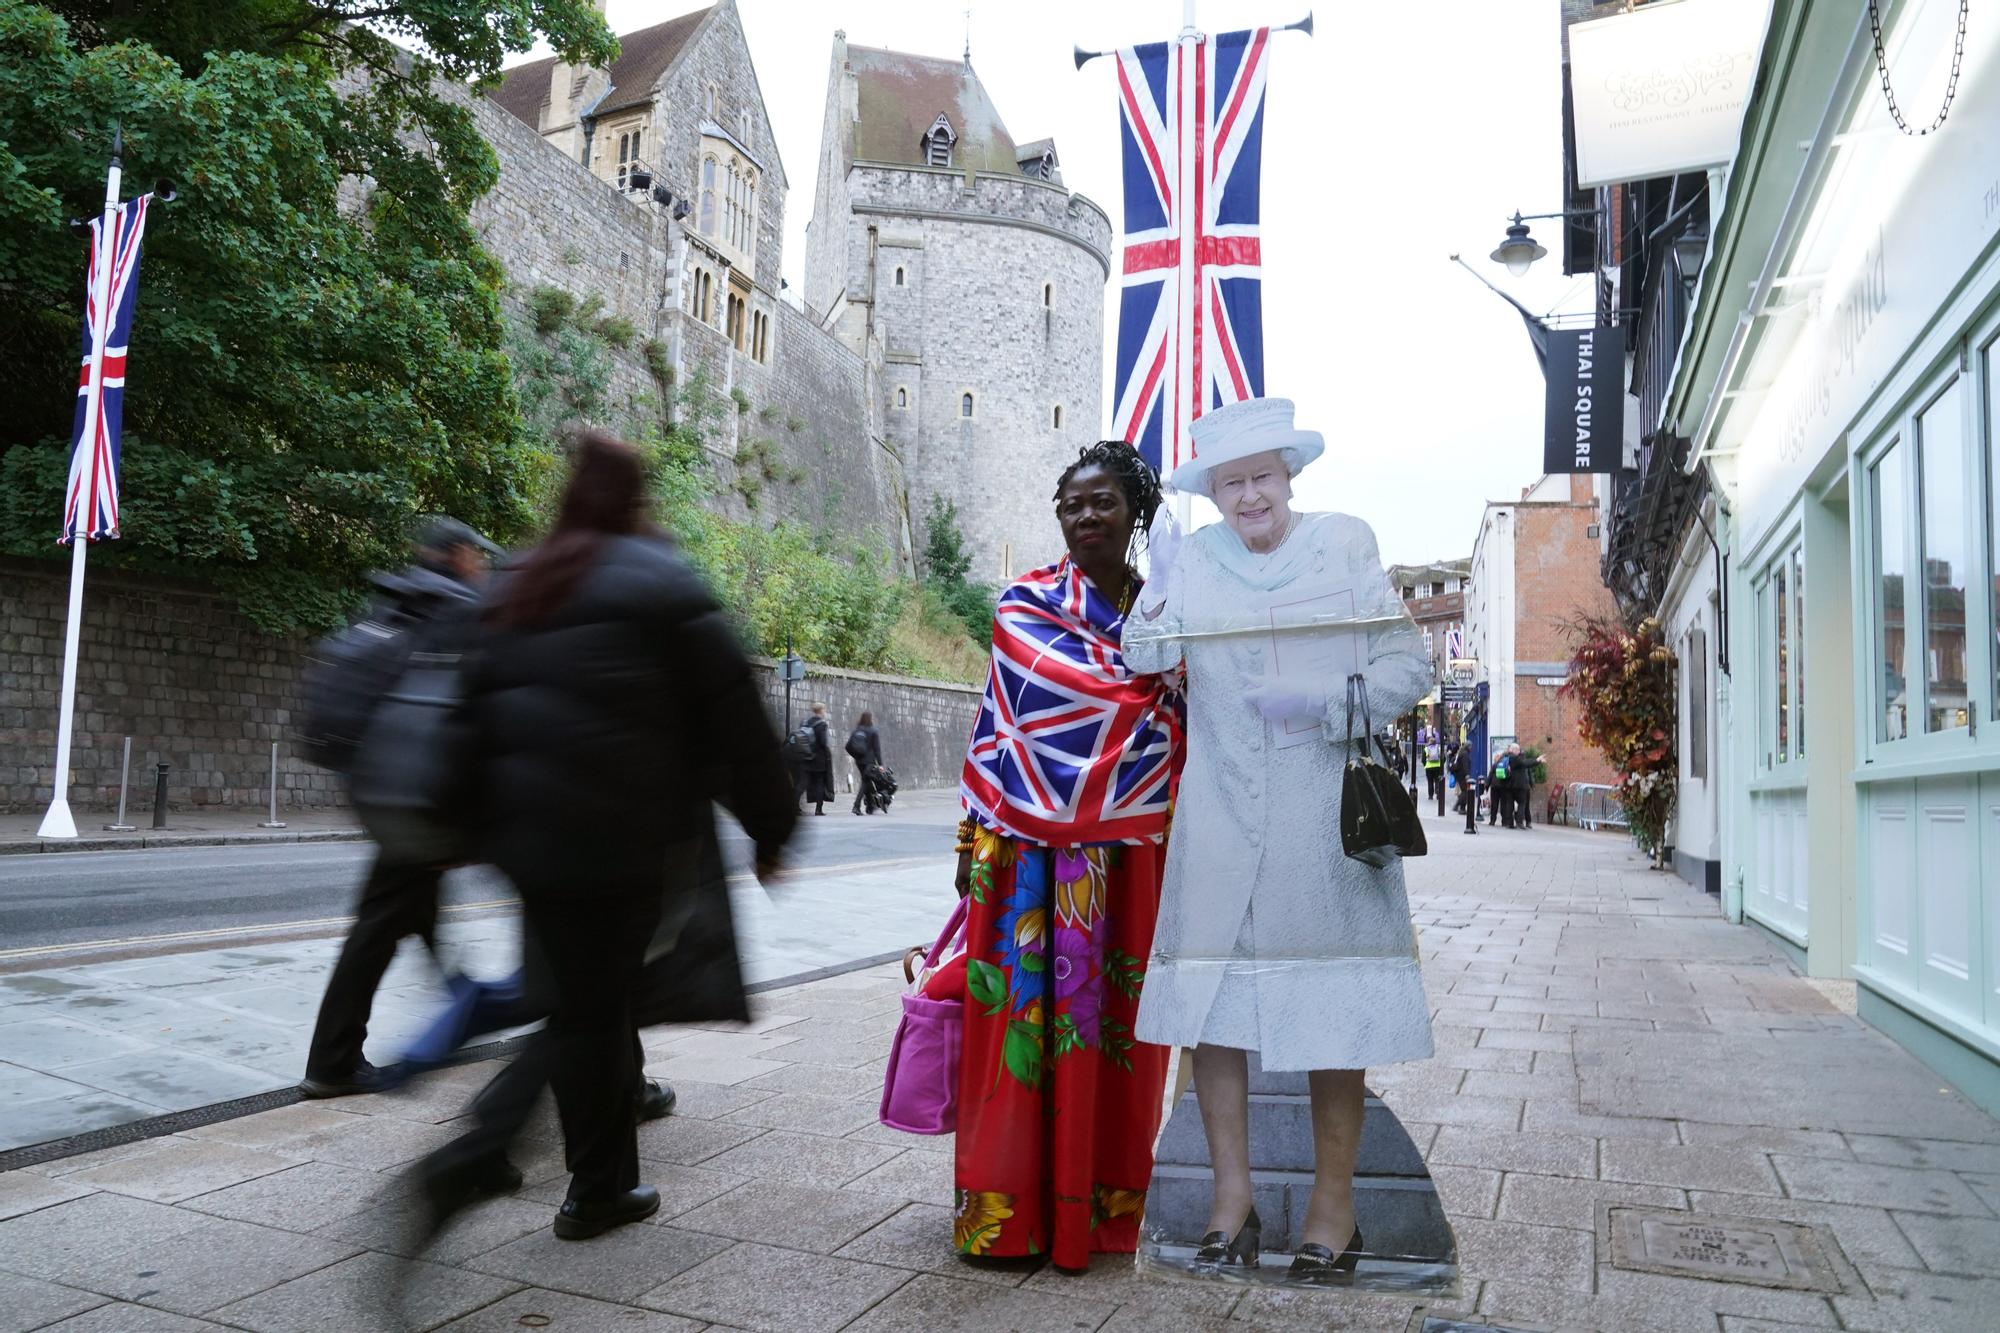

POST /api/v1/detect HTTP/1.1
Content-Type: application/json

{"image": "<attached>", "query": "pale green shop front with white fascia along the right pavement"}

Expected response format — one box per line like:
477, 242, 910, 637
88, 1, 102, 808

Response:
1668, 0, 2000, 1113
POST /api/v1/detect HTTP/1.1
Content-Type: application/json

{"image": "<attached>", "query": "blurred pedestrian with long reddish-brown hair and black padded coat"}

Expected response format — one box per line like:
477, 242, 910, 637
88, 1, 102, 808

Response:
458, 432, 794, 1239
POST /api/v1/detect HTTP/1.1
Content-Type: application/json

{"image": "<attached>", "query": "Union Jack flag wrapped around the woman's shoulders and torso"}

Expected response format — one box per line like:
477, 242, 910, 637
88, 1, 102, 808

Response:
958, 556, 1182, 847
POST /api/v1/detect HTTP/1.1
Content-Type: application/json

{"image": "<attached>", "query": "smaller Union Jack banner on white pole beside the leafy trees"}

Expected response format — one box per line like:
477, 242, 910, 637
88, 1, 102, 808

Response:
56, 194, 152, 544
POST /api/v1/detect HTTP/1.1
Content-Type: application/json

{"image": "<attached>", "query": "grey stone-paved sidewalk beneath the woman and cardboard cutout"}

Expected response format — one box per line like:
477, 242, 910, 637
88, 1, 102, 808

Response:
0, 804, 2000, 1333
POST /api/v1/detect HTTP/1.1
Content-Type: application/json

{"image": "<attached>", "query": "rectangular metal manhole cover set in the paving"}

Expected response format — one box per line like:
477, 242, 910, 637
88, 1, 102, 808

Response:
1610, 1209, 1840, 1291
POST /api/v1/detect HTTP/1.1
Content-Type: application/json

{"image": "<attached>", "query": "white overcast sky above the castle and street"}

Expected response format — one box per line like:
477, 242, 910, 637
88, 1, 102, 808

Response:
516, 0, 1590, 562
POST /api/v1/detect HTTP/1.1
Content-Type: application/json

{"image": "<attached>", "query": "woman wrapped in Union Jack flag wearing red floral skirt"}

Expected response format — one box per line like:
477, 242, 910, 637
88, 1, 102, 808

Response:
954, 440, 1182, 1269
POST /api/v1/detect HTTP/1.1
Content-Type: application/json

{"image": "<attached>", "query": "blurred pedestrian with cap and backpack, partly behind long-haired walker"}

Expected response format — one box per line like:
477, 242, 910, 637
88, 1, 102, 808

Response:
300, 518, 498, 1097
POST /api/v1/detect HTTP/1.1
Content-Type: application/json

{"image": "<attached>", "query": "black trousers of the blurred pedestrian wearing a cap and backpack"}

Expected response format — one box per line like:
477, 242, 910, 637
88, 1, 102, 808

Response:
306, 851, 444, 1079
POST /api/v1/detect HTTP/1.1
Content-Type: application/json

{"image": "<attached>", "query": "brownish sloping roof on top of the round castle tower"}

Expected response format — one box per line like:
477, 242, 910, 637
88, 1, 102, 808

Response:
848, 46, 1020, 176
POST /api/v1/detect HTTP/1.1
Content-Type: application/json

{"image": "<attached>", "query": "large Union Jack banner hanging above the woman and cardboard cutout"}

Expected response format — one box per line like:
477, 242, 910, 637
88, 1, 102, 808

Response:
1112, 28, 1270, 472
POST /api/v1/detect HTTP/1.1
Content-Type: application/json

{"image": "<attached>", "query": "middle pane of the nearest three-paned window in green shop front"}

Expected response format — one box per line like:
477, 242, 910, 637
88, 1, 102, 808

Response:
1916, 380, 1970, 733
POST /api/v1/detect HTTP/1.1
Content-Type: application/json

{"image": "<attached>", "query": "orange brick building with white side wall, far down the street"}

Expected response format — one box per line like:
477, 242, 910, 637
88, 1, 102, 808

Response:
1466, 472, 1618, 785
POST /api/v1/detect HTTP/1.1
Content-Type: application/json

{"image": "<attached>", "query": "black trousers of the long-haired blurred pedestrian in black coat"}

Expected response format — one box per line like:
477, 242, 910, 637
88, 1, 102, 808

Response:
510, 883, 660, 1201
